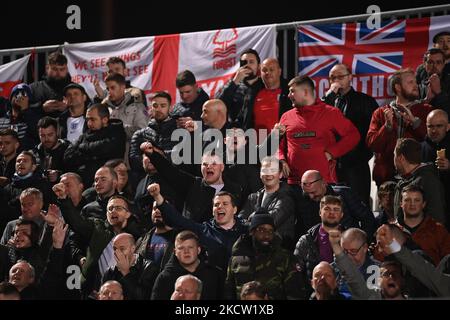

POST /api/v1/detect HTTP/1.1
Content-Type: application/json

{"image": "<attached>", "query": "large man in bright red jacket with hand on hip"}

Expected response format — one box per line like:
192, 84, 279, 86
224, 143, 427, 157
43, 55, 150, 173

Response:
278, 76, 360, 185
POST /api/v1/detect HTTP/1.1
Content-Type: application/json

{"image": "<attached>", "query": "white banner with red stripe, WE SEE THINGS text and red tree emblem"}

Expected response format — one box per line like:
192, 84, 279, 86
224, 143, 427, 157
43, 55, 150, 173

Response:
64, 25, 276, 105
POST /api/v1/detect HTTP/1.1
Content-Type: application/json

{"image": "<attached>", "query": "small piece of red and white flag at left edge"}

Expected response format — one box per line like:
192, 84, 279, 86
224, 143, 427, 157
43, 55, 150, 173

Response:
0, 55, 30, 99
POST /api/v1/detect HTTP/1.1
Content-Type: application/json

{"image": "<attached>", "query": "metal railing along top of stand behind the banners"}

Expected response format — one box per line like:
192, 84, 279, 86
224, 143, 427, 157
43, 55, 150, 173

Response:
0, 4, 450, 83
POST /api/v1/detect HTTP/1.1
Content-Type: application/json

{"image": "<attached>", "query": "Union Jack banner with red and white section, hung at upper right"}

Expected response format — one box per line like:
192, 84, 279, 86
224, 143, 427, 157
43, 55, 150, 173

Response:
298, 16, 450, 103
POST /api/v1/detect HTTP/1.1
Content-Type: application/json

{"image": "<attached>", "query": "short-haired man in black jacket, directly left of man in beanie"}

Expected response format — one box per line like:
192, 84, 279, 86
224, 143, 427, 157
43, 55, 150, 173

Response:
151, 231, 224, 300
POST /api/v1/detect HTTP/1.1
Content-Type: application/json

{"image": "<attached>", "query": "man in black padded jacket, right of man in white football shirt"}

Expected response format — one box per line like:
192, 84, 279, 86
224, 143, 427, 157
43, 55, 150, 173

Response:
64, 104, 126, 187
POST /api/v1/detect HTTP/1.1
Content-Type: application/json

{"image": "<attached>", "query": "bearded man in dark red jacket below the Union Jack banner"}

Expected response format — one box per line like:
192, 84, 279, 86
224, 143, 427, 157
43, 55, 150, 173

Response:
366, 69, 431, 186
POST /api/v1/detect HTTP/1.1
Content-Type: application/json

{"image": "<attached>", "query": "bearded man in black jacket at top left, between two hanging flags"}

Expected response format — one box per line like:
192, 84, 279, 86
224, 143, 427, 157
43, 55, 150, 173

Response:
30, 51, 72, 118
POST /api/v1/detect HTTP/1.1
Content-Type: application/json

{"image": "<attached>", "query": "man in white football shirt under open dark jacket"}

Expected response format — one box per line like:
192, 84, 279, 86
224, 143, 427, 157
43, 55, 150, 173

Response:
58, 83, 90, 143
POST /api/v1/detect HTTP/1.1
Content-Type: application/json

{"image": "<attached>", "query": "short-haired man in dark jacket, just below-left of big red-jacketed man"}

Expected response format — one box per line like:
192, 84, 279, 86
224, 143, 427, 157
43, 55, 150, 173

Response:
239, 156, 299, 251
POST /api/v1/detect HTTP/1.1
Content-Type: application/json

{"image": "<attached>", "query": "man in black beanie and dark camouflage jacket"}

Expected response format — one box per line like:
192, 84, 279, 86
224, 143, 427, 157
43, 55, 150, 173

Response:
225, 208, 305, 300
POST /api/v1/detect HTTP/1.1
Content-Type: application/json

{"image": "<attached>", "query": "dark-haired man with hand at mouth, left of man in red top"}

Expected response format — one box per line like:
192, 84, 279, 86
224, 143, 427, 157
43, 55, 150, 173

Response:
216, 48, 263, 122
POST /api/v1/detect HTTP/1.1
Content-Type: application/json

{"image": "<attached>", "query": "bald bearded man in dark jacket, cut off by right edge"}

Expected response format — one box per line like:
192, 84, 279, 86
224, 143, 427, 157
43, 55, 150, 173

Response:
422, 109, 450, 230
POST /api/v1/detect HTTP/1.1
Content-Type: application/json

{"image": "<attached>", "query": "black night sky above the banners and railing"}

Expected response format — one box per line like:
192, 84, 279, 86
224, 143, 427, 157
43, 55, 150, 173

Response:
0, 0, 449, 49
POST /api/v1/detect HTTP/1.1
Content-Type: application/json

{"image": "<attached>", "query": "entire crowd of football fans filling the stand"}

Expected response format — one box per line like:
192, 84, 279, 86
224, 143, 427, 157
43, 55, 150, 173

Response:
0, 32, 450, 300
